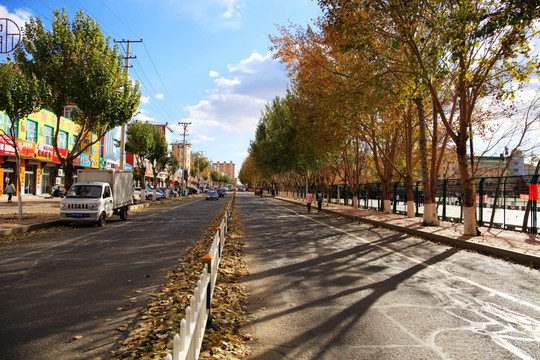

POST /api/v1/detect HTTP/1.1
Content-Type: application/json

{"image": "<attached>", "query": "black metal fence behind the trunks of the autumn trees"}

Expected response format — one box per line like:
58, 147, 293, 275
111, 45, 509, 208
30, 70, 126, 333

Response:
278, 175, 539, 234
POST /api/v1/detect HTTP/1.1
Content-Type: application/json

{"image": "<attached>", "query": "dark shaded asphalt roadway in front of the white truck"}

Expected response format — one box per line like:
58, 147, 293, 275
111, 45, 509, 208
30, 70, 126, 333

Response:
0, 198, 223, 360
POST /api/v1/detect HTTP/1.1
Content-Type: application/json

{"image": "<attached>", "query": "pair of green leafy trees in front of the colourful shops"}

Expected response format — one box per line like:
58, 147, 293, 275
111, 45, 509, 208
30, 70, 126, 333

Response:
0, 10, 141, 218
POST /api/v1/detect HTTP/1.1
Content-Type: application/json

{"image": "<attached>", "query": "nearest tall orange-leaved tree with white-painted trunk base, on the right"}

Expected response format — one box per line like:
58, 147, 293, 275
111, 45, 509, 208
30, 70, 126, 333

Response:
319, 0, 540, 235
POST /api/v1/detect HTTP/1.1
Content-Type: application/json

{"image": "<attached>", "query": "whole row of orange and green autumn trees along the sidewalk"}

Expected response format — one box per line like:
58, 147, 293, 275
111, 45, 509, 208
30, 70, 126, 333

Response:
240, 0, 540, 235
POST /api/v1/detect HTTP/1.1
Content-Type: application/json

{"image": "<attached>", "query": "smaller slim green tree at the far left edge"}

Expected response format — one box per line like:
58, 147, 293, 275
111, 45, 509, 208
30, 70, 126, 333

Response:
0, 62, 40, 220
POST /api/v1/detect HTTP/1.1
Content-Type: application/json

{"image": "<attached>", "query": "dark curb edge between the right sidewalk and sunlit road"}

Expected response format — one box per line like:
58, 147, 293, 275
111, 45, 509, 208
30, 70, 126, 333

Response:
277, 198, 540, 267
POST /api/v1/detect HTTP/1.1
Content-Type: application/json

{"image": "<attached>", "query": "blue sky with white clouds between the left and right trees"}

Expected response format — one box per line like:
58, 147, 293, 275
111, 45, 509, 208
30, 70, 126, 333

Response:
0, 0, 320, 174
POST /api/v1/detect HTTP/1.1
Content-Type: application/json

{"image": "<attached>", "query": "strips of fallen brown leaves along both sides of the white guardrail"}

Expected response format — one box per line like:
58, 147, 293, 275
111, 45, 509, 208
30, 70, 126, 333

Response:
112, 197, 251, 360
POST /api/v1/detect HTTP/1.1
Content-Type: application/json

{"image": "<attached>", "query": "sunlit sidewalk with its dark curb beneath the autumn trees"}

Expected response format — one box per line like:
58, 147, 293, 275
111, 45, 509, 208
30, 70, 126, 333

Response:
276, 196, 540, 267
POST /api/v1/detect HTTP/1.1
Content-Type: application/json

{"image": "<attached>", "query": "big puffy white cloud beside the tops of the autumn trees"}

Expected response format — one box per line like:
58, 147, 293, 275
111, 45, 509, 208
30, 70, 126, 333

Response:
186, 53, 289, 133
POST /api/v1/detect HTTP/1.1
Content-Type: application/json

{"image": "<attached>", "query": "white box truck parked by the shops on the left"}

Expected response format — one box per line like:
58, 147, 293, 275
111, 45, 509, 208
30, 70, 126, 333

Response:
60, 169, 133, 226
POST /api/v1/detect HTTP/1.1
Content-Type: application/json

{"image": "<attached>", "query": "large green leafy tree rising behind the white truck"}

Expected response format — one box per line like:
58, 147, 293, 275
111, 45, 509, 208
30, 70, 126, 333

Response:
16, 9, 140, 187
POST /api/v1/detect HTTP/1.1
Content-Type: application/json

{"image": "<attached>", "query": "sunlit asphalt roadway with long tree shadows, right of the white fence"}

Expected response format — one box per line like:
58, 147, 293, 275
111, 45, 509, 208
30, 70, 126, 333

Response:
236, 195, 540, 360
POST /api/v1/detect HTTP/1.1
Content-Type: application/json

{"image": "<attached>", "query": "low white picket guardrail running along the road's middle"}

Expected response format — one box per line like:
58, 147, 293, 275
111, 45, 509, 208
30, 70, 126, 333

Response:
165, 195, 235, 360
